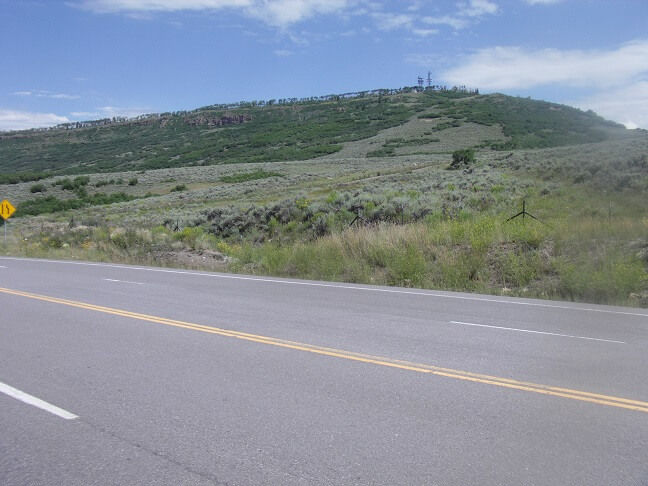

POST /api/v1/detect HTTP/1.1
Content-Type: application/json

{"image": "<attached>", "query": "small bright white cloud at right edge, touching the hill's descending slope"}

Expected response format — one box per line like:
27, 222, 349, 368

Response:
569, 81, 648, 129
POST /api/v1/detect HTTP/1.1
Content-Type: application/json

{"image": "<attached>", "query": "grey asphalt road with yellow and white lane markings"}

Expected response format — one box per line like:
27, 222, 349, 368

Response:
0, 258, 648, 485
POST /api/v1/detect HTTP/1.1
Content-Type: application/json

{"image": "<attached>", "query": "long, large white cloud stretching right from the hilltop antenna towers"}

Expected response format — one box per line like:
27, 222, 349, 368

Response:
443, 40, 648, 90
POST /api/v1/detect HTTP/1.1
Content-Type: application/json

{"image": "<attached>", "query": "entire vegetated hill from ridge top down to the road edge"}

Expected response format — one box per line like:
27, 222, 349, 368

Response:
0, 89, 648, 306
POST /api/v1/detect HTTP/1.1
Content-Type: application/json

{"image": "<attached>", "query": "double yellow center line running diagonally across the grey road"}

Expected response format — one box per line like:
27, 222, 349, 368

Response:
0, 288, 648, 413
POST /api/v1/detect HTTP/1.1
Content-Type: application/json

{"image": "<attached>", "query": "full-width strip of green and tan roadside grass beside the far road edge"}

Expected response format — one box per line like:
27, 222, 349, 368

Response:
5, 187, 648, 307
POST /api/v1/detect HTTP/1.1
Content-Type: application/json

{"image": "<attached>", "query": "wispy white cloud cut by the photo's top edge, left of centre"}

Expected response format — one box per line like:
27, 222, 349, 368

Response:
75, 0, 356, 27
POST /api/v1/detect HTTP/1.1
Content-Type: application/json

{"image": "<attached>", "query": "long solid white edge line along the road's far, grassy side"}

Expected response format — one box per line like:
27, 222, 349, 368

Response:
0, 257, 648, 317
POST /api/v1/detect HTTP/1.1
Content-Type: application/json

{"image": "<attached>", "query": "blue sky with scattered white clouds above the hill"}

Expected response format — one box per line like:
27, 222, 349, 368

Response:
0, 0, 648, 130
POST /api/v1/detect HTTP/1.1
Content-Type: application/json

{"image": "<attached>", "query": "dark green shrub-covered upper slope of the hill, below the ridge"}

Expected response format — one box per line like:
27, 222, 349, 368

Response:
0, 90, 622, 181
